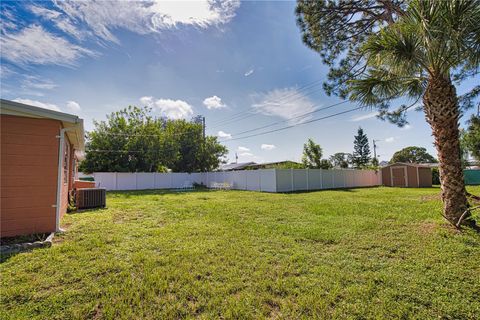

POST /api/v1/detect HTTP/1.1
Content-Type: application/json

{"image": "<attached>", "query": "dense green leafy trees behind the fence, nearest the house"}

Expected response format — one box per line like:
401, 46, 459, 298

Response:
79, 106, 228, 172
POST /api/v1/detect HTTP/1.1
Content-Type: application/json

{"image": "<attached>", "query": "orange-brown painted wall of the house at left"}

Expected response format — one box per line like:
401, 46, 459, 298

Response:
0, 115, 73, 237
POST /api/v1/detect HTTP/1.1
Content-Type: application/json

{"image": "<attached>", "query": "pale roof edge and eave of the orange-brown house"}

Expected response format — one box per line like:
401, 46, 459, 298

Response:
0, 99, 85, 152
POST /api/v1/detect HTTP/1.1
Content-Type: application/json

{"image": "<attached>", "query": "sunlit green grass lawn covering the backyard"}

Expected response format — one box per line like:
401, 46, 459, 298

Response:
0, 187, 480, 319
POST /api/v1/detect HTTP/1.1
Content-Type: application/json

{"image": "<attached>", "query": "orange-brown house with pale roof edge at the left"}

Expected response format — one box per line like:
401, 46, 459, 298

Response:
0, 99, 84, 237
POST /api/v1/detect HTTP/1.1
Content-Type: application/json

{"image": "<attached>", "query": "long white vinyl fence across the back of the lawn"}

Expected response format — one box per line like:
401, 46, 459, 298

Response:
84, 169, 382, 192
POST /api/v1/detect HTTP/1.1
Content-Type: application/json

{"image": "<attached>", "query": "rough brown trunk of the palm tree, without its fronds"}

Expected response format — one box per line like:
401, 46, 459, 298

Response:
423, 76, 468, 224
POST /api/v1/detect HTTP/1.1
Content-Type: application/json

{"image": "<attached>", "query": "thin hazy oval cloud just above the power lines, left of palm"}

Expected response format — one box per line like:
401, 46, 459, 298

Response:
252, 88, 315, 124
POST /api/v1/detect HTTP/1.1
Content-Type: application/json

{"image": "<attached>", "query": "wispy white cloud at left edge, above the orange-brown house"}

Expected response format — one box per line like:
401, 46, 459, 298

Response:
0, 25, 96, 66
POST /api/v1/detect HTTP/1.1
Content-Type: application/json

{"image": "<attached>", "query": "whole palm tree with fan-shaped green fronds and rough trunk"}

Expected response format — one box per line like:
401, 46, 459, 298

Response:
349, 0, 480, 225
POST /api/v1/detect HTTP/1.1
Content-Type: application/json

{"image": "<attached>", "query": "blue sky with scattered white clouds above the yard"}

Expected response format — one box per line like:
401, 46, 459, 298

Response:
1, 1, 479, 162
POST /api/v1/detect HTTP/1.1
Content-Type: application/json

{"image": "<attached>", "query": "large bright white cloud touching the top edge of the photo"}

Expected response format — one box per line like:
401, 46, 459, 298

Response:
51, 0, 240, 43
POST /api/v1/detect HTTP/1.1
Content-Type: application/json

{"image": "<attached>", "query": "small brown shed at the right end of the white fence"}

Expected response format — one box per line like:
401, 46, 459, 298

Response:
382, 162, 432, 188
